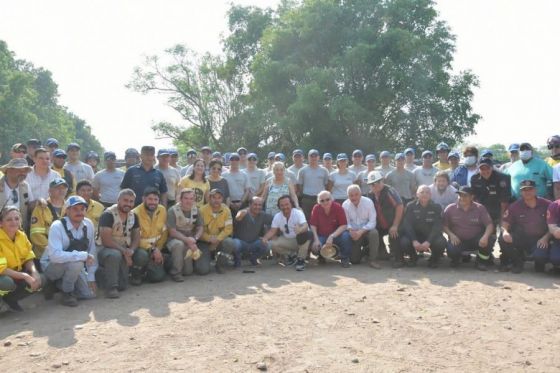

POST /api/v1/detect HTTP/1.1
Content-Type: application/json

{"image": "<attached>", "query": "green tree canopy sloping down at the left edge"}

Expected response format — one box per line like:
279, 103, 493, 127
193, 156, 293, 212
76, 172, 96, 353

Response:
0, 40, 103, 162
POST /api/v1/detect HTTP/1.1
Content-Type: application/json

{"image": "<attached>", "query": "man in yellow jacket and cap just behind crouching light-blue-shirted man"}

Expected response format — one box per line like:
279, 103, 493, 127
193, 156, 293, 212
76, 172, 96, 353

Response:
29, 178, 68, 260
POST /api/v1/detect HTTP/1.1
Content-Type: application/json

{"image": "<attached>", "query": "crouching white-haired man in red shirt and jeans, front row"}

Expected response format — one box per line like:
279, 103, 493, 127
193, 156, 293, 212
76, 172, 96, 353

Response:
310, 190, 352, 268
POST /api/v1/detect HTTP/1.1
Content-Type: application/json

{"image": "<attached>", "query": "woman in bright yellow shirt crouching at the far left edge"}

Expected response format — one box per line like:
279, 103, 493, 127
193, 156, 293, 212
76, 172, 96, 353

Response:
0, 206, 45, 312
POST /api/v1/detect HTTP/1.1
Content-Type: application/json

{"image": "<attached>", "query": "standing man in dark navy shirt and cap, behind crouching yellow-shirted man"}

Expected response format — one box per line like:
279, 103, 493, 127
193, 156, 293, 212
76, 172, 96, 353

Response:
121, 145, 167, 206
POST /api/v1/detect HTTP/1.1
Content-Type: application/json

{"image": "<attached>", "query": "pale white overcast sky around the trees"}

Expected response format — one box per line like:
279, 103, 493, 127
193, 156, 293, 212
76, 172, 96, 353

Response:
0, 0, 560, 156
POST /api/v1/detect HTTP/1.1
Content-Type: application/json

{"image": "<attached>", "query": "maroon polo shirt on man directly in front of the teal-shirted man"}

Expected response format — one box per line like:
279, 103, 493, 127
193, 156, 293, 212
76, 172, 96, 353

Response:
503, 197, 552, 237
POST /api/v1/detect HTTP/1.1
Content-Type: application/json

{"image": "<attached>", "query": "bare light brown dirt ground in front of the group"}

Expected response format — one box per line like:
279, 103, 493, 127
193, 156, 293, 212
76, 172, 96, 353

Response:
0, 261, 560, 373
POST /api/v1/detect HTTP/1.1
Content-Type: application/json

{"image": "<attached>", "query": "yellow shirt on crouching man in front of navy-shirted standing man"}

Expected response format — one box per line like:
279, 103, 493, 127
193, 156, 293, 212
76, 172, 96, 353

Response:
133, 203, 168, 250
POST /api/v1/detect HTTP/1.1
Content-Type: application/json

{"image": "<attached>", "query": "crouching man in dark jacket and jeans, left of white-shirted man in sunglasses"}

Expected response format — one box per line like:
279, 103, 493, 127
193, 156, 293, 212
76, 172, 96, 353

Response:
233, 197, 272, 267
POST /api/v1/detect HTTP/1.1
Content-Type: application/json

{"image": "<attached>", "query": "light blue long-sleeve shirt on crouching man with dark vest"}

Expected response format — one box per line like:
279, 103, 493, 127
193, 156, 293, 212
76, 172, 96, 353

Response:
41, 217, 97, 281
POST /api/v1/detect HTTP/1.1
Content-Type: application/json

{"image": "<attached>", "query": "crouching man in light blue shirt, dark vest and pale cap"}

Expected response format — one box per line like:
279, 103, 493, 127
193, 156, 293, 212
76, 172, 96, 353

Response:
41, 196, 97, 307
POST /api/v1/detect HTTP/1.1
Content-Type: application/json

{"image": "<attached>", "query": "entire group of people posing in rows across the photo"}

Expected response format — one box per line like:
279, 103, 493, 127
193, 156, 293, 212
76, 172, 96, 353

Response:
0, 136, 560, 311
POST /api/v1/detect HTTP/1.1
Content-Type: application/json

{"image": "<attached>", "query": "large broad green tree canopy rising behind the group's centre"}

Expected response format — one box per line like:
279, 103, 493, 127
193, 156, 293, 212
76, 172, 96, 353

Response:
129, 0, 480, 152
